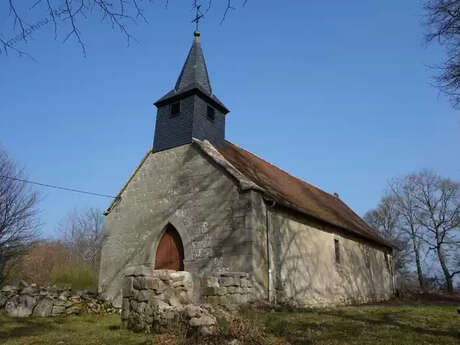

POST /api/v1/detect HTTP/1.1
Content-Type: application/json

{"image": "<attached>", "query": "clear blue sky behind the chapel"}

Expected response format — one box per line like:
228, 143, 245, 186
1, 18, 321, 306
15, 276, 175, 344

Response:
0, 0, 460, 236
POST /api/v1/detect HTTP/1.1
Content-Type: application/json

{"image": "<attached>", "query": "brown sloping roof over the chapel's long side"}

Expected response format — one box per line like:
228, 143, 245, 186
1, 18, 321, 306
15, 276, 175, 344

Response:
217, 141, 393, 247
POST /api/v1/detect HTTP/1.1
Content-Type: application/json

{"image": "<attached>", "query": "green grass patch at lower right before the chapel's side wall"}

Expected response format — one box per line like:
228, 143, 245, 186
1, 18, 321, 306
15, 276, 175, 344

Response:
260, 306, 460, 345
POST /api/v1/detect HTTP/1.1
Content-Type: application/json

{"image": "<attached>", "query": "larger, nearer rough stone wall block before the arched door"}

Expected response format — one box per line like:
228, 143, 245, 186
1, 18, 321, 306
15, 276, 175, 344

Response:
121, 266, 216, 335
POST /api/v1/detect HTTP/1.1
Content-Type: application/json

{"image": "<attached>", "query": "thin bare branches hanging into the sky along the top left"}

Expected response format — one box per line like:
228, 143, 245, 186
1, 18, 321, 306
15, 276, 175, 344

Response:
0, 0, 247, 56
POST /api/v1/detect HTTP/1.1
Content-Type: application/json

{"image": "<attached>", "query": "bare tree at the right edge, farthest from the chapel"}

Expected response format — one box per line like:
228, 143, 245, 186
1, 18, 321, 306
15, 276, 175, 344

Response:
413, 171, 460, 292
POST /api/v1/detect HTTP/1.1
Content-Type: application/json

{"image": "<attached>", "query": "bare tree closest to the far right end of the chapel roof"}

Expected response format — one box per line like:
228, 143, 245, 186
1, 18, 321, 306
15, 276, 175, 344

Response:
364, 195, 409, 276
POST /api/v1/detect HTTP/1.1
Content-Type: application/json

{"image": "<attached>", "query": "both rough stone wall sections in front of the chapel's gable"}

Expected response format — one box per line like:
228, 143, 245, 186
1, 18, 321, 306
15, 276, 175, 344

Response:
121, 266, 253, 335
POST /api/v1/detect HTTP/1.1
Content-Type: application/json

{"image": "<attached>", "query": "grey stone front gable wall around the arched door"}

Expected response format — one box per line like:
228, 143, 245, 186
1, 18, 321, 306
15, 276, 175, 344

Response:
99, 144, 254, 306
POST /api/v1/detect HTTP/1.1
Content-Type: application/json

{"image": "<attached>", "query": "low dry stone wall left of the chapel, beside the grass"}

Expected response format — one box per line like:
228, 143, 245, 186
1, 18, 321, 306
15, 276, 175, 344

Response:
0, 282, 120, 317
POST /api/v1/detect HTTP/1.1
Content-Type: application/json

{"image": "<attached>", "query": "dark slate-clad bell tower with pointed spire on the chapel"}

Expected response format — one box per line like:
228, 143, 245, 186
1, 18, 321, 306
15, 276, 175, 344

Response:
153, 30, 229, 152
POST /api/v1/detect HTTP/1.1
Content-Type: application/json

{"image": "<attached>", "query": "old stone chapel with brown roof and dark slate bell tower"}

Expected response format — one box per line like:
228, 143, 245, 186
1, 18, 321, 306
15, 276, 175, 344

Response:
99, 31, 394, 306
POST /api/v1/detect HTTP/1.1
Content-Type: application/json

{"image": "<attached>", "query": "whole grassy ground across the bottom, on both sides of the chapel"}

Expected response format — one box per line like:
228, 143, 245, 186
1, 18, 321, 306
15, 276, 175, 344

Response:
0, 295, 460, 345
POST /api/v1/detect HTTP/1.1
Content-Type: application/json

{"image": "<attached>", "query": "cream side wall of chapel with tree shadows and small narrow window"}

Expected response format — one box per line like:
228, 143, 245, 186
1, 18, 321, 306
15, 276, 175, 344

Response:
270, 206, 393, 306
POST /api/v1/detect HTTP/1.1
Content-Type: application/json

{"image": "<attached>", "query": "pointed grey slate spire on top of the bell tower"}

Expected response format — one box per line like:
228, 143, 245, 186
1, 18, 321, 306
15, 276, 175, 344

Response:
175, 30, 212, 95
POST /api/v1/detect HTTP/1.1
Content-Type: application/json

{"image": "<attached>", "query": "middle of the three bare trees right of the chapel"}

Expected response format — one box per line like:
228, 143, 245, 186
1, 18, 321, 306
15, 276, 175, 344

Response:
389, 175, 426, 290
